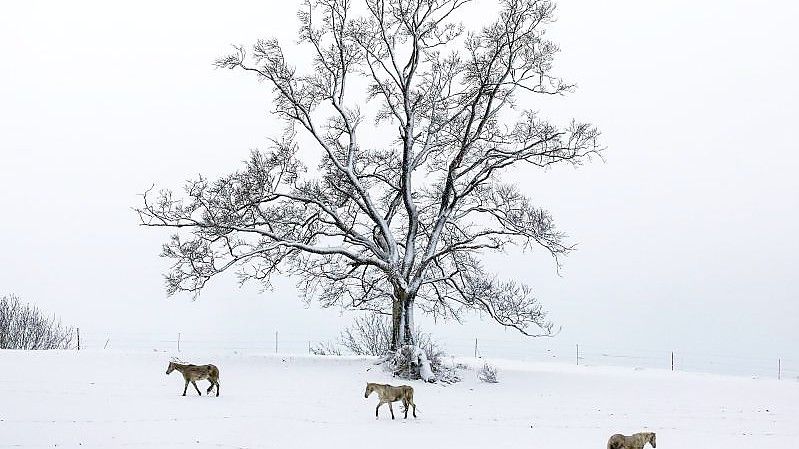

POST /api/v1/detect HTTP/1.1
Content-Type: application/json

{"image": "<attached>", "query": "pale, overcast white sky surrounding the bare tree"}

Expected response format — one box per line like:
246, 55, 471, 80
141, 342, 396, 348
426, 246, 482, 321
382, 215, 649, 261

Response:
0, 0, 799, 359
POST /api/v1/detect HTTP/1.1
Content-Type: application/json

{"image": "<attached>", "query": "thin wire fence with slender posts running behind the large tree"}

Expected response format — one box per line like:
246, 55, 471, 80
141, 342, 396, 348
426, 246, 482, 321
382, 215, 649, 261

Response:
72, 330, 799, 381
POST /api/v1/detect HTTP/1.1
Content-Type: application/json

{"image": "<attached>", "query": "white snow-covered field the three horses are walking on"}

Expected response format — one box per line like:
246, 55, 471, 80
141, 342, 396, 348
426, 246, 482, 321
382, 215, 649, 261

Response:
0, 351, 799, 449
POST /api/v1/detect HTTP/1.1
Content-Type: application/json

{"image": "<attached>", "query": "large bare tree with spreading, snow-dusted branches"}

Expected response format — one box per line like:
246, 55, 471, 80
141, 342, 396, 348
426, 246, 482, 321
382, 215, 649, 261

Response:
137, 0, 599, 364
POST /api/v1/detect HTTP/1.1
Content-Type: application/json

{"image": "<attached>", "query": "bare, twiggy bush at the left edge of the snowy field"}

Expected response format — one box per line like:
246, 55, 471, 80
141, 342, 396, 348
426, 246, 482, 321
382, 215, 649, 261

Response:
0, 295, 75, 349
